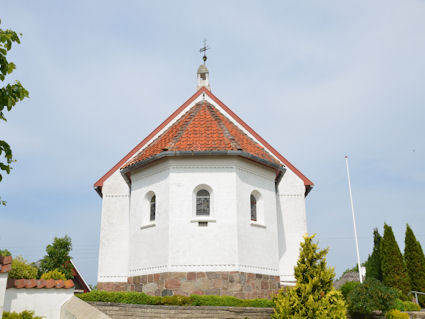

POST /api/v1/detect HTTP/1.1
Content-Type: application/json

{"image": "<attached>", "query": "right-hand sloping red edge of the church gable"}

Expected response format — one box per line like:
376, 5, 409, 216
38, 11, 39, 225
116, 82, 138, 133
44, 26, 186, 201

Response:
205, 90, 314, 188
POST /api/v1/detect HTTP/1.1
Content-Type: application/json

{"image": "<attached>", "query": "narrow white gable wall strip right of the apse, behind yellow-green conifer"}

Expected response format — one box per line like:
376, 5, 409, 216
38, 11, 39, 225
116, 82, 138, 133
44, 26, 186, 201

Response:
276, 169, 307, 284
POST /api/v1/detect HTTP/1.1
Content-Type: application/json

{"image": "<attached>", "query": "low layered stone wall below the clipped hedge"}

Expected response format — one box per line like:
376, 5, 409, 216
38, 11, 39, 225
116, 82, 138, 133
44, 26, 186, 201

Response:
89, 302, 273, 319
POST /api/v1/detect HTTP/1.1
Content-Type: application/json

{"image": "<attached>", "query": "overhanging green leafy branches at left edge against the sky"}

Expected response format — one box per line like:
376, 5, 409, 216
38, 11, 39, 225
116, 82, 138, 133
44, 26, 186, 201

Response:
0, 20, 29, 205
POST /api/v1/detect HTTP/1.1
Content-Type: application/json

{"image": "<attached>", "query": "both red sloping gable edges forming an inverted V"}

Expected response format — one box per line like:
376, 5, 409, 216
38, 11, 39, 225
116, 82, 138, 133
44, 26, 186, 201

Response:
94, 87, 313, 195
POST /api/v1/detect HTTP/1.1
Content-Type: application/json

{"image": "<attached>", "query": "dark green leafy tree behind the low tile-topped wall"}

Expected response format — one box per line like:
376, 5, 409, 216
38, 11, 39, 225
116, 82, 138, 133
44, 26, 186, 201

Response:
40, 235, 73, 279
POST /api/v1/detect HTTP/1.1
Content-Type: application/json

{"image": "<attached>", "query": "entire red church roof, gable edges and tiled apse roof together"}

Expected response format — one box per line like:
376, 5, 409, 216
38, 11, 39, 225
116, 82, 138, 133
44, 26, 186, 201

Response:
94, 87, 313, 195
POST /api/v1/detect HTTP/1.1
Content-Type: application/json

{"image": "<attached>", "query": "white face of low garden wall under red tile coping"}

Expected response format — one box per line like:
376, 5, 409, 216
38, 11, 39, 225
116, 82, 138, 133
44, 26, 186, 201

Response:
4, 288, 74, 319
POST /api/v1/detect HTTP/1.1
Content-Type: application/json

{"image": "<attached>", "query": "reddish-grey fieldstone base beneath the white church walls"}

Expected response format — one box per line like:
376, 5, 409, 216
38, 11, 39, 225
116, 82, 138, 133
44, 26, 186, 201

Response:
97, 271, 280, 299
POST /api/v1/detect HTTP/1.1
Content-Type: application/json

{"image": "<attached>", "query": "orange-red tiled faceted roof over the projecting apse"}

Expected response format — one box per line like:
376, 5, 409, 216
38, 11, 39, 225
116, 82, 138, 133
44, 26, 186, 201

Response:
123, 101, 282, 168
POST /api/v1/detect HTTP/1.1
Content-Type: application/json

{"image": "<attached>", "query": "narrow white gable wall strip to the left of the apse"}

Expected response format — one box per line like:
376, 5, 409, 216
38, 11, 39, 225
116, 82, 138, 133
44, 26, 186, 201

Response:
98, 171, 130, 282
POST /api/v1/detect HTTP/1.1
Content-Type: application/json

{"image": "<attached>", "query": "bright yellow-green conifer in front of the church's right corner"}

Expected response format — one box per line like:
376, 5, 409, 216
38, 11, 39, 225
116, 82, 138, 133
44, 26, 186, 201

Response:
272, 235, 347, 319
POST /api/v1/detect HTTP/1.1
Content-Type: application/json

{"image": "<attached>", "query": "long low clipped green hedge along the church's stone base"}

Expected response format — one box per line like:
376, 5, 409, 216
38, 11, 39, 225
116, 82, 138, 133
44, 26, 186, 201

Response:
76, 290, 273, 307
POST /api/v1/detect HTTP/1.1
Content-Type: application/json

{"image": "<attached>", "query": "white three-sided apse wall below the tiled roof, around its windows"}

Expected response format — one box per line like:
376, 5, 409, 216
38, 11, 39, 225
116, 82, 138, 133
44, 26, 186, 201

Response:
129, 156, 279, 276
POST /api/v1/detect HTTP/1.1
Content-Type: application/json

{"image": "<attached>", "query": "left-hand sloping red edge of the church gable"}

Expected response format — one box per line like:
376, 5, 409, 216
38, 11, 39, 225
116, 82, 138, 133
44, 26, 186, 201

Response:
94, 87, 208, 195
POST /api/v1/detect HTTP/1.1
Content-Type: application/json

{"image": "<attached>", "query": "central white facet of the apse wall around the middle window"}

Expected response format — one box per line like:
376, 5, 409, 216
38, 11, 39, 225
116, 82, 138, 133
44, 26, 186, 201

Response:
169, 157, 238, 272
